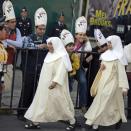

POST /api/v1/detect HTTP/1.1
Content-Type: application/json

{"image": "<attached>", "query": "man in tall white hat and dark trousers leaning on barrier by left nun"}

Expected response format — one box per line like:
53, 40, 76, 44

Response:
17, 8, 48, 120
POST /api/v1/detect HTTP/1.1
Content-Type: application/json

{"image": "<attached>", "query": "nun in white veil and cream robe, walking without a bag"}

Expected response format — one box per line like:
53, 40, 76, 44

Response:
24, 37, 75, 130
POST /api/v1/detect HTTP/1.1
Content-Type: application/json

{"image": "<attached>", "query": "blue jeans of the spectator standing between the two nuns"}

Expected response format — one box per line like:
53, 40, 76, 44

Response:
76, 68, 88, 107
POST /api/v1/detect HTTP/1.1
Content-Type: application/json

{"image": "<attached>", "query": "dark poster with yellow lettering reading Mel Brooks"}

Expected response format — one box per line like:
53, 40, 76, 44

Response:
87, 0, 131, 27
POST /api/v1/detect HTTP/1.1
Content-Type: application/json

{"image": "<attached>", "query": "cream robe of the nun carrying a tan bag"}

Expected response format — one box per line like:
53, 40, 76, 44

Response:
85, 60, 129, 126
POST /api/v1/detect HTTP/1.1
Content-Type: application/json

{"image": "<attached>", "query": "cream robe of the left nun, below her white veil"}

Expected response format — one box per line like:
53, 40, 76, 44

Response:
24, 58, 75, 123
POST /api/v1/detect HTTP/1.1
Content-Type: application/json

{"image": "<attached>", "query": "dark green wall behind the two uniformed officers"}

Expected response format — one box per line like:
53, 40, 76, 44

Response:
12, 0, 79, 34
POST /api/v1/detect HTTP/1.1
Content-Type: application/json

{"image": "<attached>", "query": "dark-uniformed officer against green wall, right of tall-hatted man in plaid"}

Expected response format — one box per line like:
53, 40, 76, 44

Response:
51, 12, 67, 37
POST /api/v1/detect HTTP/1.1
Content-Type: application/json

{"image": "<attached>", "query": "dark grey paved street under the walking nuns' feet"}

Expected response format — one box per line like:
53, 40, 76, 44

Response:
0, 115, 131, 131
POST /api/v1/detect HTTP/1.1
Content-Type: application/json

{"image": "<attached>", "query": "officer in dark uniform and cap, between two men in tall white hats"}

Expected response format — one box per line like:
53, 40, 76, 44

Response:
16, 7, 32, 36
